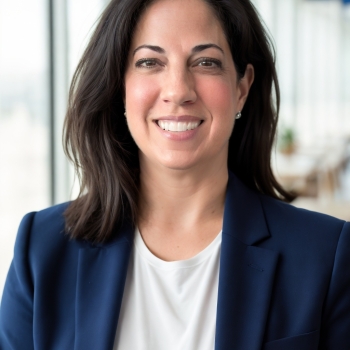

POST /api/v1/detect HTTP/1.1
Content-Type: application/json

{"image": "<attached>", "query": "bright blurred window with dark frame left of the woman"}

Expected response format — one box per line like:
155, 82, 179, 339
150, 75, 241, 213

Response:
0, 0, 107, 298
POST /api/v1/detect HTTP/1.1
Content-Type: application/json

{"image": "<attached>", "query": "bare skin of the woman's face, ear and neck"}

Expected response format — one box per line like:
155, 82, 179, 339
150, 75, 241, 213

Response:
125, 0, 254, 261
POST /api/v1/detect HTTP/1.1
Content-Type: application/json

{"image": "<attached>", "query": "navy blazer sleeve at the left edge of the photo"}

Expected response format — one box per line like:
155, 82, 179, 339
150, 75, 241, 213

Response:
0, 213, 35, 350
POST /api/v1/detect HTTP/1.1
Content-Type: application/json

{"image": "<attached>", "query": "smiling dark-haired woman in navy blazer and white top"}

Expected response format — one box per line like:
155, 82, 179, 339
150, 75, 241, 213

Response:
1, 0, 350, 350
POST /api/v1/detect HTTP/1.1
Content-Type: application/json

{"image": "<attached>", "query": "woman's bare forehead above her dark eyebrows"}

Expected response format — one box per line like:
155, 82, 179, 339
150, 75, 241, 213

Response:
131, 0, 227, 49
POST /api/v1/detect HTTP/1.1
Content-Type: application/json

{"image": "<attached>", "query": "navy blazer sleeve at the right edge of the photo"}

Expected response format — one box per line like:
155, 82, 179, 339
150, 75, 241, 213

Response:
319, 223, 350, 350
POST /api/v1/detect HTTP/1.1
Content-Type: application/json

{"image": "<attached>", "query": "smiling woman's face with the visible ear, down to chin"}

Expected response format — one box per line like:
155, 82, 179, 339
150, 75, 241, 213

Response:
125, 0, 253, 169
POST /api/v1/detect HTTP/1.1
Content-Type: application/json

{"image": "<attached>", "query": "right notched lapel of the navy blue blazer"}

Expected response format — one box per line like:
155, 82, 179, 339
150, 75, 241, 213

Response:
215, 174, 278, 350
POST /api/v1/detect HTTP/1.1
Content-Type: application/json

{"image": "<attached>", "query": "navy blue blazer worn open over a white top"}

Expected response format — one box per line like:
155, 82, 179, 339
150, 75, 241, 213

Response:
0, 175, 350, 350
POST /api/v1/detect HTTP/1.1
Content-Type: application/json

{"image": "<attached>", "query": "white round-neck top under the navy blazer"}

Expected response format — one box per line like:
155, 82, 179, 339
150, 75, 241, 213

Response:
114, 230, 221, 350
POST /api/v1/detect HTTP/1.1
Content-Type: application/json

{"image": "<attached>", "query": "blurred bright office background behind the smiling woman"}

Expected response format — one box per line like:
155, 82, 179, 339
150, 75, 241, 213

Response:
0, 0, 350, 297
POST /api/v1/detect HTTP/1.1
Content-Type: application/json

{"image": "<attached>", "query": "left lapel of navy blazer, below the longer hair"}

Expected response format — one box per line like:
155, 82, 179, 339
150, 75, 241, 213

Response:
74, 221, 133, 350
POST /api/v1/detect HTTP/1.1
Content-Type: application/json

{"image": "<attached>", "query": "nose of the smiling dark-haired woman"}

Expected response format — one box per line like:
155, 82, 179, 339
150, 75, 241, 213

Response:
161, 67, 197, 106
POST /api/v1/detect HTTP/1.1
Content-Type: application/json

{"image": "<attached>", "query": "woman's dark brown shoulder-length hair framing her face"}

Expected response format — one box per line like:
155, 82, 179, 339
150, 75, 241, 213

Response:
64, 0, 291, 243
